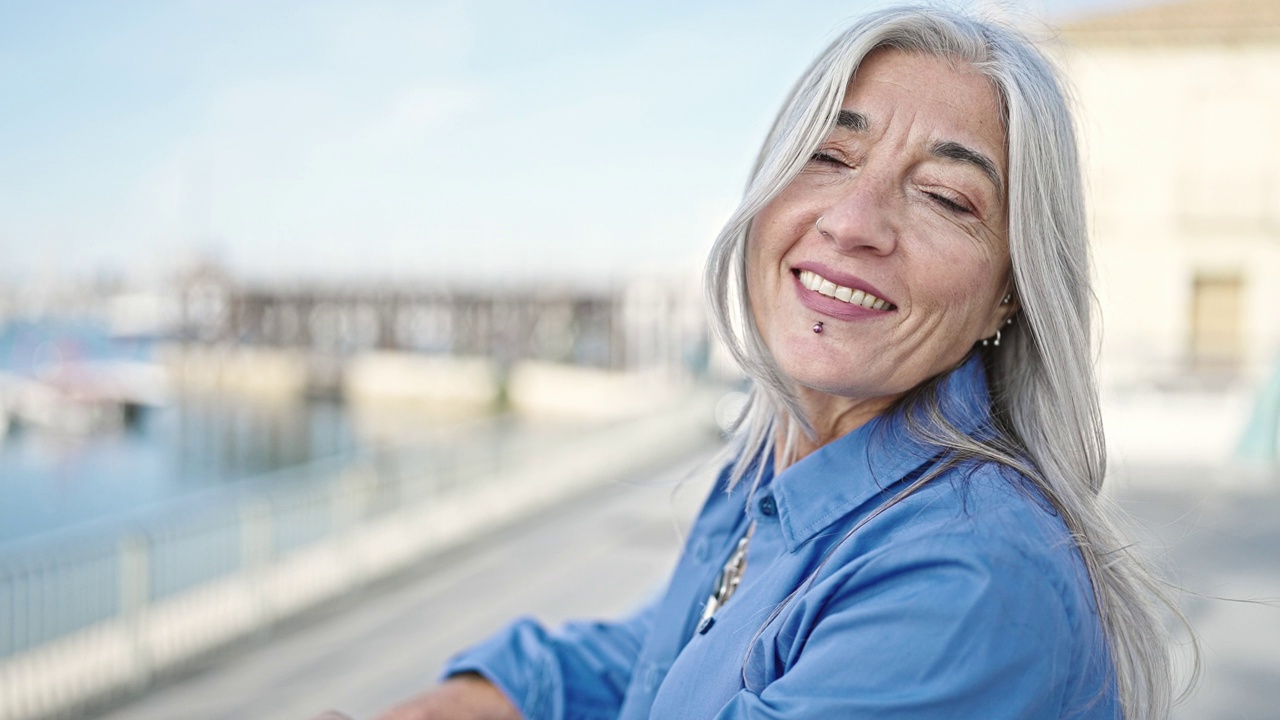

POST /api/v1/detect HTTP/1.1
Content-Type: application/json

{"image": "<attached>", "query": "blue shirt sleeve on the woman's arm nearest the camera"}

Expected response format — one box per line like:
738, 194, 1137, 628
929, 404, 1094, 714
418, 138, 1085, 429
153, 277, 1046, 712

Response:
718, 536, 1090, 720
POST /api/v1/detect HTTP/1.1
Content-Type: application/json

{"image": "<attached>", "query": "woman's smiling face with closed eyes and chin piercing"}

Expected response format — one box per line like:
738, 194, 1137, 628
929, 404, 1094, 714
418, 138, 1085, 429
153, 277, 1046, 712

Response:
748, 50, 1011, 400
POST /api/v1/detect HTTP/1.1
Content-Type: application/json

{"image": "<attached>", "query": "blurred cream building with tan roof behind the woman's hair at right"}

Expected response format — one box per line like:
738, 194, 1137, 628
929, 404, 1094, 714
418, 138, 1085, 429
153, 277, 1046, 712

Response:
1061, 0, 1280, 389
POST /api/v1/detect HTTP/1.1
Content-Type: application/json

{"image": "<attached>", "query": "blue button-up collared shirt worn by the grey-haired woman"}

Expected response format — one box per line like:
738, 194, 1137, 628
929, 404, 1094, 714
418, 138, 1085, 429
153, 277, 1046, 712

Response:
444, 357, 1120, 720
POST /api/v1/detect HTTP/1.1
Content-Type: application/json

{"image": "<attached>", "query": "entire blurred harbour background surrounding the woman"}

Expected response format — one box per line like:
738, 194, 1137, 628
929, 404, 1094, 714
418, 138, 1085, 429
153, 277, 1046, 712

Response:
0, 0, 1280, 720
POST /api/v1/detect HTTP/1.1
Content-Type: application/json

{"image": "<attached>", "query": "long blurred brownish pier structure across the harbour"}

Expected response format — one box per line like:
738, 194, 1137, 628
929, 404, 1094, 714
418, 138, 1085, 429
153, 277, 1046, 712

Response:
177, 270, 708, 384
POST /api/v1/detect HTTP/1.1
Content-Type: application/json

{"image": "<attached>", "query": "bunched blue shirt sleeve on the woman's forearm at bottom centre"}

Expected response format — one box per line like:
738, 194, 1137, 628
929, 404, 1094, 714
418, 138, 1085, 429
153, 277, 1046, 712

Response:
442, 598, 660, 720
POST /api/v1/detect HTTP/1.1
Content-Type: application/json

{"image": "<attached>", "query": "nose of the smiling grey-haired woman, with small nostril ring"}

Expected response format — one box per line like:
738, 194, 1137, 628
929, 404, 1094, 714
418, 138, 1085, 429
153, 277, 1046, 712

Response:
814, 173, 902, 255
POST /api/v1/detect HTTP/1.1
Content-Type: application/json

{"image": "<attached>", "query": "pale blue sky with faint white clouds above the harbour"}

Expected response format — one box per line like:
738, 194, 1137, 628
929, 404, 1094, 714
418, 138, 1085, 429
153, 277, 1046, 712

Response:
0, 0, 1141, 281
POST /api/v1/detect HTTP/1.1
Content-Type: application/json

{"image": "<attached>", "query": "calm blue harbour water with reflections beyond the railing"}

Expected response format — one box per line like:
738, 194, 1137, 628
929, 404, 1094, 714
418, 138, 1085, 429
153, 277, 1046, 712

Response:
0, 320, 577, 550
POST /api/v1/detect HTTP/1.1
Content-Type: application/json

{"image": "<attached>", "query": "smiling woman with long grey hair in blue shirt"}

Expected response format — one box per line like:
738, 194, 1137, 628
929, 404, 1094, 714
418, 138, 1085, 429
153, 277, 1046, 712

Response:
337, 9, 1170, 720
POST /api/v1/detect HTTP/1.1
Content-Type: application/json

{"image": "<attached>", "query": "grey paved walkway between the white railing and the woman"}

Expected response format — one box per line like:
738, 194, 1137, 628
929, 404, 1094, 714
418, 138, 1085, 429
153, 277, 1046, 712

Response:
104, 445, 713, 720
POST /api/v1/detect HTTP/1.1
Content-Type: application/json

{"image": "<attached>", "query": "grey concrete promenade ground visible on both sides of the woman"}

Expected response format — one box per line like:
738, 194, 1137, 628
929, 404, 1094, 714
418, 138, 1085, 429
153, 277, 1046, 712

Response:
105, 456, 1280, 720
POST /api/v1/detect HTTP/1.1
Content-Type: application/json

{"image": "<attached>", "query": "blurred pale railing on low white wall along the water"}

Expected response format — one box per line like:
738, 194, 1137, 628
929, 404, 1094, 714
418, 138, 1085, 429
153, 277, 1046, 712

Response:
0, 396, 716, 720
